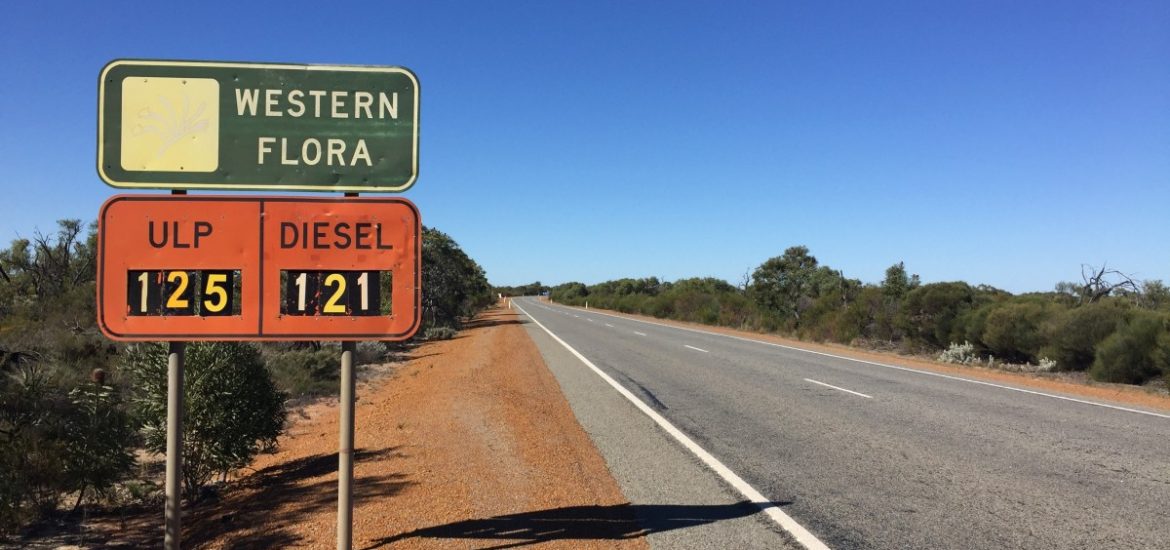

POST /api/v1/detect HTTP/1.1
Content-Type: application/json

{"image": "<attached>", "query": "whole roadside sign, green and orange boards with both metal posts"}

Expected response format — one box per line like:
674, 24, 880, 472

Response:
97, 60, 421, 550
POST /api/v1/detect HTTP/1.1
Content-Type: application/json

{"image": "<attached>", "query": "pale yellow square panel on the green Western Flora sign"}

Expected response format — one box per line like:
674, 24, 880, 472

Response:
122, 76, 219, 172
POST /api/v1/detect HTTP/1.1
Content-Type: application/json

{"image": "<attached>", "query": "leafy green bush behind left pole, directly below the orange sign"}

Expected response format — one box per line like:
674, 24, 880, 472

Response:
123, 342, 287, 501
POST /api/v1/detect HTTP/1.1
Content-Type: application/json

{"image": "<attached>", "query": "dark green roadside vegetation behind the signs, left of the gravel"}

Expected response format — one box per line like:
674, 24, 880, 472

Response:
0, 220, 493, 535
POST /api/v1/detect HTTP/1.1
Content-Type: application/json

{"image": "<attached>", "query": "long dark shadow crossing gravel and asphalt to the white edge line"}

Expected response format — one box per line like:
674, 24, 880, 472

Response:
364, 501, 787, 550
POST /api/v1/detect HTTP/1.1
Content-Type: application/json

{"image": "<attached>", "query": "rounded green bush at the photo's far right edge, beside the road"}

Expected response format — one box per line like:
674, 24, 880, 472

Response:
1089, 310, 1170, 384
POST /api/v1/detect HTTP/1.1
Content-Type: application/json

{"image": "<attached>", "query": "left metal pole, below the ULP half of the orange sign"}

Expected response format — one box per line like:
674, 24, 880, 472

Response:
163, 342, 187, 550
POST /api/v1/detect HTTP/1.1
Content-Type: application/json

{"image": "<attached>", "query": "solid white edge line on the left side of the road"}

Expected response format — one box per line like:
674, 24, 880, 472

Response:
517, 305, 828, 550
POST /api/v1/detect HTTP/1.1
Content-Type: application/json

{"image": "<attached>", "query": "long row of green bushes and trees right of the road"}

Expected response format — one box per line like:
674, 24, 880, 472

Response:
551, 246, 1170, 384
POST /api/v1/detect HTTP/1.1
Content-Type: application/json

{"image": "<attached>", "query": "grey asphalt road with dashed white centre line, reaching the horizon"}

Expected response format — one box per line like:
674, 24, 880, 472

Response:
514, 298, 1170, 549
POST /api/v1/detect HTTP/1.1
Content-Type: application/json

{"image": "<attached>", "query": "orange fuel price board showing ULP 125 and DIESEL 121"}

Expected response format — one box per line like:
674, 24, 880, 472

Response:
97, 195, 421, 341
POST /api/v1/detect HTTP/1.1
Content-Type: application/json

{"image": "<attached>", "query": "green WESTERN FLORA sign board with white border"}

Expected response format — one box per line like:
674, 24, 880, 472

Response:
97, 60, 419, 192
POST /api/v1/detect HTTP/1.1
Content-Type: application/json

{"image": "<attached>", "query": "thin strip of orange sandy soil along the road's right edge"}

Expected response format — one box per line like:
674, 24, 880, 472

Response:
552, 304, 1170, 411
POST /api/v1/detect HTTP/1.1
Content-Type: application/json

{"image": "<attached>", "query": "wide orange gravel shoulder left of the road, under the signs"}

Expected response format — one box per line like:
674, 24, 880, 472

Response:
67, 310, 646, 549
